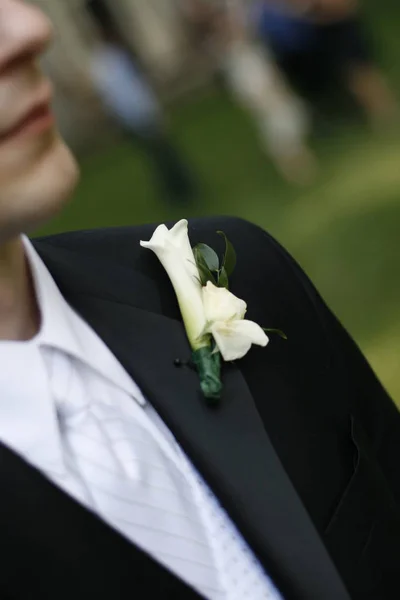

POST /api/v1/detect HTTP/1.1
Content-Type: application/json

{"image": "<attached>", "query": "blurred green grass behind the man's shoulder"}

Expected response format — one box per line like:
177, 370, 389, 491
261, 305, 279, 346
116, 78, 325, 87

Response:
39, 0, 400, 406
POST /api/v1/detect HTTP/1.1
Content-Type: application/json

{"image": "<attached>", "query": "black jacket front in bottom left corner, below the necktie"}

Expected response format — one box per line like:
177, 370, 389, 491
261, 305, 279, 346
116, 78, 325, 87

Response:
0, 444, 200, 600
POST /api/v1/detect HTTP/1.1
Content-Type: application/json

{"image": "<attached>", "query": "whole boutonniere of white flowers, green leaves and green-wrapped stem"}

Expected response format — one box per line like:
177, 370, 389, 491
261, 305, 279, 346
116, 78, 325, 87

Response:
140, 219, 285, 403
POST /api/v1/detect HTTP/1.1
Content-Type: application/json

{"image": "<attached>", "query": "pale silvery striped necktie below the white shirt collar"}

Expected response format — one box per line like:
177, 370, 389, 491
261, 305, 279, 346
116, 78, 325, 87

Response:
45, 352, 224, 600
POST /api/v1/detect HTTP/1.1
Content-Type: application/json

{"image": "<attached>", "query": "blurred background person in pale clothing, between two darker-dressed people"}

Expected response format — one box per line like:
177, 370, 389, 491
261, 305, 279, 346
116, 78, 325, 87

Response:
182, 0, 316, 184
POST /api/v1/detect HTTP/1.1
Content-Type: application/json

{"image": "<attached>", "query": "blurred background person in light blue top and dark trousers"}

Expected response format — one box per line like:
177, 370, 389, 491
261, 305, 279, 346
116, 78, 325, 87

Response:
86, 0, 197, 203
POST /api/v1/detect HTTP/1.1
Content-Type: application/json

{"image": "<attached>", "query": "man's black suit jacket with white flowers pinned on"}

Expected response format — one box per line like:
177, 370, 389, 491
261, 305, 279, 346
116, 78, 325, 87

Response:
0, 218, 400, 600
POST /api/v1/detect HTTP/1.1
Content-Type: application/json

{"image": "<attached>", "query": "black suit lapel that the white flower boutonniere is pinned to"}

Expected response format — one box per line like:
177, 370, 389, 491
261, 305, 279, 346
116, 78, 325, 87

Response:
36, 243, 349, 600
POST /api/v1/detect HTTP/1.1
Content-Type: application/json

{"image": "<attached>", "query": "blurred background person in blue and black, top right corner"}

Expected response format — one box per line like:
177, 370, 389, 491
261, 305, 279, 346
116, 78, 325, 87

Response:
253, 0, 398, 127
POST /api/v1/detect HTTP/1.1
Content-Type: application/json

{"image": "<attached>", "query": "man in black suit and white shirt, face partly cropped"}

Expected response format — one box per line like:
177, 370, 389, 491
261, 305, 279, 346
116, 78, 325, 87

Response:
0, 0, 400, 600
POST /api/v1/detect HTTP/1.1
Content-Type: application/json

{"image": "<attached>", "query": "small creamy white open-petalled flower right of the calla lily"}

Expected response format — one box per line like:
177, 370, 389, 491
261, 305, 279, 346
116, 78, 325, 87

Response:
202, 281, 269, 361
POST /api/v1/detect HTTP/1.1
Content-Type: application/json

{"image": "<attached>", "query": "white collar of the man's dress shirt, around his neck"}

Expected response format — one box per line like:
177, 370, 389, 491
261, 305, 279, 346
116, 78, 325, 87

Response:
0, 237, 146, 476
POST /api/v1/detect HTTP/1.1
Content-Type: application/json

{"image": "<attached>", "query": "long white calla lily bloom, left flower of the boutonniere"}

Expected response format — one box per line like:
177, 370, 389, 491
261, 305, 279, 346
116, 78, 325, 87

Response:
140, 219, 209, 350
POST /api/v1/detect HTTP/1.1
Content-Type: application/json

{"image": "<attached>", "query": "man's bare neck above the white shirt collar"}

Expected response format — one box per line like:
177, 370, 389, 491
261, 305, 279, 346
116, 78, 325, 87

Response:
0, 238, 40, 341
